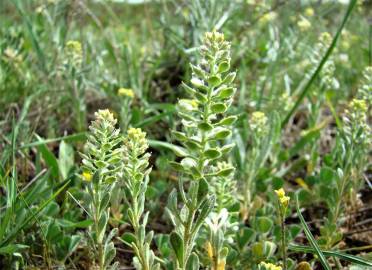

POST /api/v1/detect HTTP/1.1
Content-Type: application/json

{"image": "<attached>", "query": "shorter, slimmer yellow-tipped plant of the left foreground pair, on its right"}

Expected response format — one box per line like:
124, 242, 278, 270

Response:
123, 128, 160, 270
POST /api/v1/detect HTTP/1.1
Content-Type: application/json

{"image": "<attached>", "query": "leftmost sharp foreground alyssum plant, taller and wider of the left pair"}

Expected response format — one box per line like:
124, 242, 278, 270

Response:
81, 110, 122, 270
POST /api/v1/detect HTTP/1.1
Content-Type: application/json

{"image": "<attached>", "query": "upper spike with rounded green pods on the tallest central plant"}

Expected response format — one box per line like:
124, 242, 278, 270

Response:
173, 29, 237, 180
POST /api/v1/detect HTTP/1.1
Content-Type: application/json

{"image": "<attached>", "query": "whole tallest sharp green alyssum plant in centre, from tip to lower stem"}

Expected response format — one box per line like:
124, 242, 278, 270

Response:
168, 31, 236, 269
